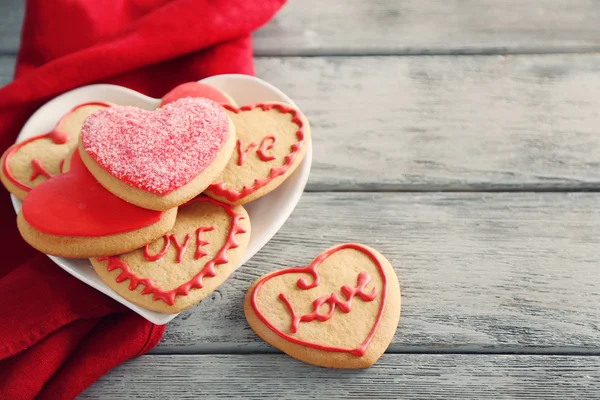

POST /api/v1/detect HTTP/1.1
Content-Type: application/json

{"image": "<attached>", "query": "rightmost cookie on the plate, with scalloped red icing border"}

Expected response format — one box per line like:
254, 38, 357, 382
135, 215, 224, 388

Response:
205, 103, 310, 204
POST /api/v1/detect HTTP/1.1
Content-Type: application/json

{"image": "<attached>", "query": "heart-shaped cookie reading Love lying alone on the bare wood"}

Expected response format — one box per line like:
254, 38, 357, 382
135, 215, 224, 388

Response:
244, 243, 400, 368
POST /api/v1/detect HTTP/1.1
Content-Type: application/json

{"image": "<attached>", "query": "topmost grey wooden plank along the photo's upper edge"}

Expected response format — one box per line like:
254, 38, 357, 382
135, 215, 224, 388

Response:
0, 0, 600, 55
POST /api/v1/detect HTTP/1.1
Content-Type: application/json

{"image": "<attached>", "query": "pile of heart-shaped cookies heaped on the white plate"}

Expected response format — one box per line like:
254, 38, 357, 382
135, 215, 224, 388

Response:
0, 82, 310, 313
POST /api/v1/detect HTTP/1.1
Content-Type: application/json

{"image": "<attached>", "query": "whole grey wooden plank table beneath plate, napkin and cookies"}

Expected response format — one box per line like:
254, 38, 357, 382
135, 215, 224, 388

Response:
0, 0, 600, 399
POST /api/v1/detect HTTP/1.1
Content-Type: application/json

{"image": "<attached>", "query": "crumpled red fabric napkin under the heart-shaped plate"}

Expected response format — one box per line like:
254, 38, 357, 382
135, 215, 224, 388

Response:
0, 0, 285, 399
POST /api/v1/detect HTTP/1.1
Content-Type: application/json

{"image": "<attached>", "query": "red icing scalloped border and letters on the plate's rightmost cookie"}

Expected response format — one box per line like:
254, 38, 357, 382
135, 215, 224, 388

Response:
207, 103, 305, 201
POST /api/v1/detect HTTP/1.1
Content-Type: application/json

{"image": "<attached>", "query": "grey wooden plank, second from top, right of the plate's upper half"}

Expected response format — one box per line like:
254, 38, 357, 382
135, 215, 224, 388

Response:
0, 54, 600, 191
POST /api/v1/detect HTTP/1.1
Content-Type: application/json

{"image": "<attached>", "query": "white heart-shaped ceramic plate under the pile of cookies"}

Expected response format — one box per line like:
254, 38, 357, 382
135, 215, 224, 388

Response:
12, 74, 312, 325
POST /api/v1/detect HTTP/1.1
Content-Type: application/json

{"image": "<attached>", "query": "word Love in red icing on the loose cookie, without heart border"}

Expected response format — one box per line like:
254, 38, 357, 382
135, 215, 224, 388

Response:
279, 272, 377, 333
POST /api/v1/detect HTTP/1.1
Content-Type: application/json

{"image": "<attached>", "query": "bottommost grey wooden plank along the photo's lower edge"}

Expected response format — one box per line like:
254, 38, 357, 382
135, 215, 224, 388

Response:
80, 354, 600, 400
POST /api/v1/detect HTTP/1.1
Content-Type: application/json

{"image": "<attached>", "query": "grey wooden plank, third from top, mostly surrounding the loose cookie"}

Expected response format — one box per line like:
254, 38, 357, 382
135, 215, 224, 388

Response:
153, 193, 600, 354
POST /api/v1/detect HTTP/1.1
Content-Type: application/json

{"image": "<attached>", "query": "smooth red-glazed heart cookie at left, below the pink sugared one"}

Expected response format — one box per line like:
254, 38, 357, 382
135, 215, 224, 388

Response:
17, 151, 177, 258
